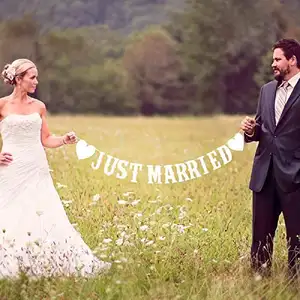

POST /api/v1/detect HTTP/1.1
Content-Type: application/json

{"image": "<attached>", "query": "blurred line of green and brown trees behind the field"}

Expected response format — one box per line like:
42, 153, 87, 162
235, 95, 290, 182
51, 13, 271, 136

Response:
0, 0, 300, 115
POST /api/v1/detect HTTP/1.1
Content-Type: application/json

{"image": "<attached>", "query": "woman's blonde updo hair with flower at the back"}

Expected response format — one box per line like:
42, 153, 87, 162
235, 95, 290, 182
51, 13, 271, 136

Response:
2, 58, 36, 85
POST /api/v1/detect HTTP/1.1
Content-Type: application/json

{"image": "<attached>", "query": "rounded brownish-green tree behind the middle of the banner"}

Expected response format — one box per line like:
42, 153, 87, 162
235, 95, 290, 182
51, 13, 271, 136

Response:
124, 29, 188, 115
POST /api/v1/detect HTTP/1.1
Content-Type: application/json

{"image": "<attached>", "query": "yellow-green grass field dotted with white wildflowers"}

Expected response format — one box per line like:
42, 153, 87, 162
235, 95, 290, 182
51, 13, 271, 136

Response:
0, 116, 300, 300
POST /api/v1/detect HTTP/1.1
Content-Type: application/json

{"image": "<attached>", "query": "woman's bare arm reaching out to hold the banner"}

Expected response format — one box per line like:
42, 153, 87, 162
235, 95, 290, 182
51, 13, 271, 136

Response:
41, 103, 76, 148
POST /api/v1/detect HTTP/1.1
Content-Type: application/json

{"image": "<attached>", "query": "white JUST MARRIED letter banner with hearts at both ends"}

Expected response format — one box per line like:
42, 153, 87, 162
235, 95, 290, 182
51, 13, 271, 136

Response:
76, 132, 245, 184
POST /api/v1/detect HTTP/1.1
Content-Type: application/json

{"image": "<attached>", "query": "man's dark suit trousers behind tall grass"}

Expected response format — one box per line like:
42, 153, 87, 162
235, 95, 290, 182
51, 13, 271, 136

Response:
251, 160, 300, 274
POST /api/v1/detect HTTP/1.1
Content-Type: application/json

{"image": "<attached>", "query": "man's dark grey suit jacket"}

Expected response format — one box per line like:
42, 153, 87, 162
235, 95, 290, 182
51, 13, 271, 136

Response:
244, 80, 300, 193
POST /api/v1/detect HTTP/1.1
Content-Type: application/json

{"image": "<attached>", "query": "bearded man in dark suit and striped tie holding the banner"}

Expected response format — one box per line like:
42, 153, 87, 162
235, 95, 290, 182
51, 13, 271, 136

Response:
241, 39, 300, 277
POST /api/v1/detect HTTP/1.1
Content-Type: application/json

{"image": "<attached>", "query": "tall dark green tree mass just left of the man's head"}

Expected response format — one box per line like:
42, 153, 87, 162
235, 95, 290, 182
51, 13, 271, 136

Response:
168, 0, 288, 113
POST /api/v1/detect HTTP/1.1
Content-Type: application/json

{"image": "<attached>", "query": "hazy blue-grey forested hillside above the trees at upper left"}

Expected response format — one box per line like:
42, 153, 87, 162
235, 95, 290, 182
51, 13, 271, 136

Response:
0, 0, 184, 33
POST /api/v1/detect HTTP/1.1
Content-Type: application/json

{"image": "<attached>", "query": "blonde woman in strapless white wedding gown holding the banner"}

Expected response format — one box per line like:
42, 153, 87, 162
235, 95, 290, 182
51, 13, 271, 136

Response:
0, 59, 111, 278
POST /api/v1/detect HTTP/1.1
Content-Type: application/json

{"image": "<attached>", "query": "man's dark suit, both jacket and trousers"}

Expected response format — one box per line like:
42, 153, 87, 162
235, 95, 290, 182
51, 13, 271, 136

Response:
245, 80, 300, 271
